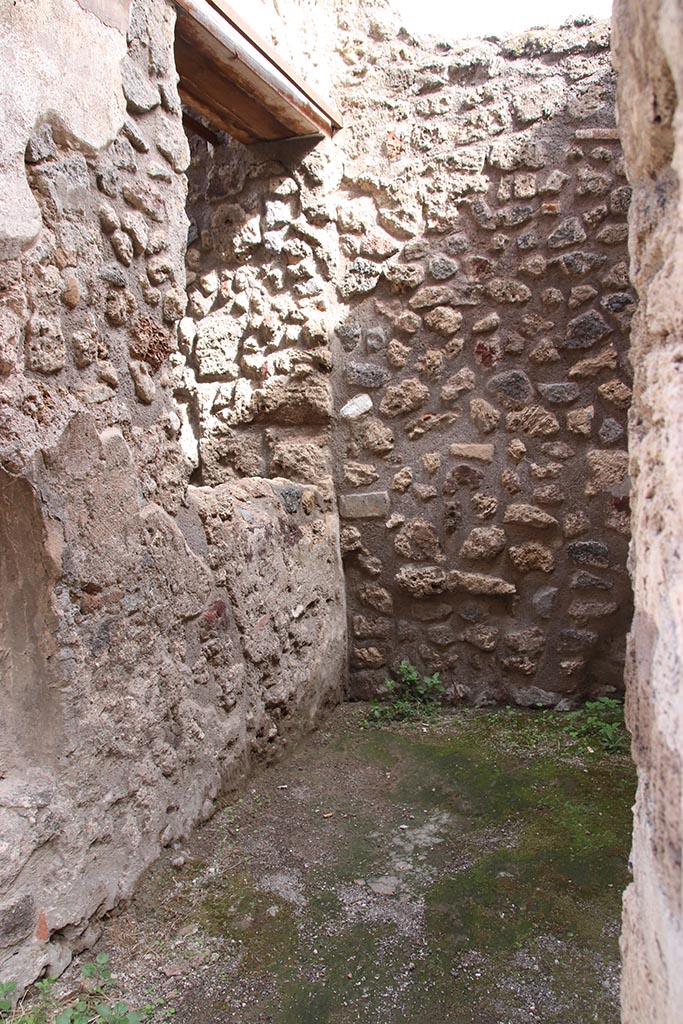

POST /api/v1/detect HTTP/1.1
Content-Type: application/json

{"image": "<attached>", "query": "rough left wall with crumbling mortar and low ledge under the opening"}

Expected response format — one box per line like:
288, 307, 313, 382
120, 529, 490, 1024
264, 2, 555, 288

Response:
0, 0, 345, 984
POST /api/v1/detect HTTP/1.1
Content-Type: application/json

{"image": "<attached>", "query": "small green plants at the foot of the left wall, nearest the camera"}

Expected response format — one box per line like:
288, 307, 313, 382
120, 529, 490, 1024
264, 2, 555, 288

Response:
0, 953, 154, 1024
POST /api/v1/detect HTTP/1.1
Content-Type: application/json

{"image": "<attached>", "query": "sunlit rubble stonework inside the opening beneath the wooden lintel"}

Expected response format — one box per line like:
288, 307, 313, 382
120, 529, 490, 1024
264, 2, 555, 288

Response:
174, 131, 341, 496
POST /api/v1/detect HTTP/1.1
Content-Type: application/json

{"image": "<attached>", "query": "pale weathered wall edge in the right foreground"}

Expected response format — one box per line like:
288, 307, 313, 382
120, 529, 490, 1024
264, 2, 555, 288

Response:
614, 0, 683, 1024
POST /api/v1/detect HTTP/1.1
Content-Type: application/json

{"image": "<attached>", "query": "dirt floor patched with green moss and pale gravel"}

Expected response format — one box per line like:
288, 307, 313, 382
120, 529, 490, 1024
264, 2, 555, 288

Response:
66, 706, 635, 1024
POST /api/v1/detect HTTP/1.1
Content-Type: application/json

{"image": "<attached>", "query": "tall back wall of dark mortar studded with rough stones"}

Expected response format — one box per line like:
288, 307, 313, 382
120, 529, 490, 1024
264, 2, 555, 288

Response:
335, 19, 634, 706
